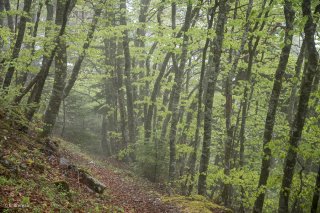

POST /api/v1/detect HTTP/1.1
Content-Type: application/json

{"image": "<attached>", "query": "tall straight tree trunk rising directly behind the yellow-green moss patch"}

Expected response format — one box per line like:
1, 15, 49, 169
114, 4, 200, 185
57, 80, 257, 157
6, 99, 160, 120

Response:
198, 0, 228, 195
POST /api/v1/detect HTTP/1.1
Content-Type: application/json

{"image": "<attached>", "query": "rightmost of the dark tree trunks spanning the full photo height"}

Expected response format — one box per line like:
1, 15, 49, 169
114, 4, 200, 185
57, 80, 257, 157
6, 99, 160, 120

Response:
278, 0, 320, 213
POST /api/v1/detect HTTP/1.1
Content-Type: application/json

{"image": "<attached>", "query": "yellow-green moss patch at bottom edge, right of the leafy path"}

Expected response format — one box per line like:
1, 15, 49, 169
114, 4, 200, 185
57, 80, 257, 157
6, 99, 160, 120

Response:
162, 195, 232, 213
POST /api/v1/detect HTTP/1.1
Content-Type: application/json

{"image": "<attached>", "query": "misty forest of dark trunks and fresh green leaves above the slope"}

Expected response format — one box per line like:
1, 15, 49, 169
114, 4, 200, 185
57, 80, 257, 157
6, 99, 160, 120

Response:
0, 0, 320, 213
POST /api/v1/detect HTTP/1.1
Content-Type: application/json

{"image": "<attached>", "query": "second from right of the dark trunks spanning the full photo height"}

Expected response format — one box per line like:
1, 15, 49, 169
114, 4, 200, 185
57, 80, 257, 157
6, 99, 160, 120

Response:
253, 0, 295, 213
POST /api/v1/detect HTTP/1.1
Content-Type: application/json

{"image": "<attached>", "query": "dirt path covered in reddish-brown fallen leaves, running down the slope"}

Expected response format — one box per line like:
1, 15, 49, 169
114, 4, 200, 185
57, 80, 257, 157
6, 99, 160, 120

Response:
63, 148, 180, 213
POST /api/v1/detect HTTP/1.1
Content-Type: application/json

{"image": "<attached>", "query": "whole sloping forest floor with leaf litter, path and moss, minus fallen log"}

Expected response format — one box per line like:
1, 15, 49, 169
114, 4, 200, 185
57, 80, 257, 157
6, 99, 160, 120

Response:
0, 113, 229, 213
